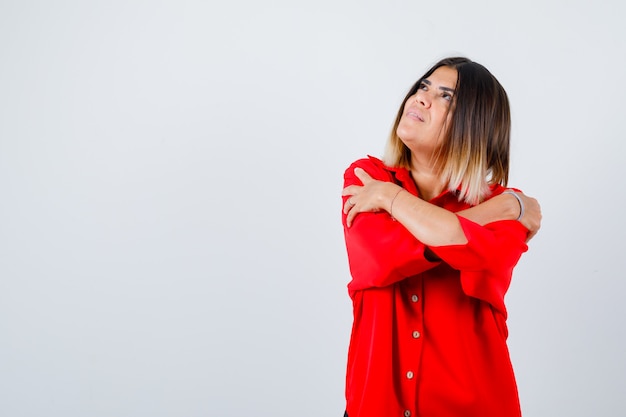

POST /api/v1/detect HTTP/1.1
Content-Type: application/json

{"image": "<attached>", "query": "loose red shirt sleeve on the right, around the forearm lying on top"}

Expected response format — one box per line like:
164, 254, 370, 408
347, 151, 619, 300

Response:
430, 216, 528, 317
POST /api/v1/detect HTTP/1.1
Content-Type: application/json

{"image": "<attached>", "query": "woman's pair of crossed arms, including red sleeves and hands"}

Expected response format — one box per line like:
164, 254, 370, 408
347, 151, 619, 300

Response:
342, 161, 541, 300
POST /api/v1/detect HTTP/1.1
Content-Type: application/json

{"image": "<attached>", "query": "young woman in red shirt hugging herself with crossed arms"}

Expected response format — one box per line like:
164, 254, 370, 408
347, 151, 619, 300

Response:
343, 58, 541, 417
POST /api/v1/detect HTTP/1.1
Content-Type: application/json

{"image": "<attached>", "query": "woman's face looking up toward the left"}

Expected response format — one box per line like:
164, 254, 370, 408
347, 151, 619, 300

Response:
396, 67, 458, 156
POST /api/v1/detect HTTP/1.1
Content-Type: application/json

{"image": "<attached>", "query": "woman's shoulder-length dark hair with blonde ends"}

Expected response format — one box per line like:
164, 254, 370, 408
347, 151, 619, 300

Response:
383, 57, 511, 205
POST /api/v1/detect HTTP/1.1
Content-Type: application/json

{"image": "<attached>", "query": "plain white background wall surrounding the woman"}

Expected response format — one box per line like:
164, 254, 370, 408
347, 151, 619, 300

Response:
0, 0, 626, 417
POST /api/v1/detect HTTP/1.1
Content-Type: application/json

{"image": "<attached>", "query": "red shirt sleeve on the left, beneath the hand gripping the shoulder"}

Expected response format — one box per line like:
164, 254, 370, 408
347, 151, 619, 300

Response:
342, 159, 439, 293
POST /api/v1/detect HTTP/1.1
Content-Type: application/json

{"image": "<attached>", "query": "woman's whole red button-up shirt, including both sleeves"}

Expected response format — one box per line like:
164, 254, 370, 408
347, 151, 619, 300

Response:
343, 157, 527, 417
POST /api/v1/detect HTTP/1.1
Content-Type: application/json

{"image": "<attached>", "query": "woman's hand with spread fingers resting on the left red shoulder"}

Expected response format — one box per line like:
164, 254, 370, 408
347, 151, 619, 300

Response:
341, 168, 402, 227
